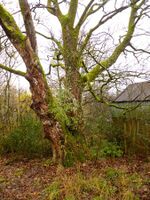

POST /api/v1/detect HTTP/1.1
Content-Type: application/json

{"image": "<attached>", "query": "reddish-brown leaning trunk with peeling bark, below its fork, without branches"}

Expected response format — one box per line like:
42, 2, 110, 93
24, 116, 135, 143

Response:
20, 39, 64, 163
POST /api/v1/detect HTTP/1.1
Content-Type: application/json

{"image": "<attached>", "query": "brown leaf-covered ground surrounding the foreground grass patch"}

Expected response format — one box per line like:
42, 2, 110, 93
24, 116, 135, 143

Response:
0, 156, 150, 200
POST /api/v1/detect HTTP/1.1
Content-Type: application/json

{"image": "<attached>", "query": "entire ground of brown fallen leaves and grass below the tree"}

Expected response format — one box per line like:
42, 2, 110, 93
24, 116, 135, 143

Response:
0, 156, 150, 200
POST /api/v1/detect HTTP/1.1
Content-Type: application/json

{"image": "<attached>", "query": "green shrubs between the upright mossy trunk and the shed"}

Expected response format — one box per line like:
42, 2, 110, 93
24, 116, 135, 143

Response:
85, 102, 123, 159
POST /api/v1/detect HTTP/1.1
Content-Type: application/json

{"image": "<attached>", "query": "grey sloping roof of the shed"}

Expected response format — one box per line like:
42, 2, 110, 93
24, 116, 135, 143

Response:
114, 81, 150, 103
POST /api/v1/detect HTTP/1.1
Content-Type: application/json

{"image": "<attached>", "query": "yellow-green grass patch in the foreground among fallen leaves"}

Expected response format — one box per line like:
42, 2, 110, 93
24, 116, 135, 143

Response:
43, 168, 142, 200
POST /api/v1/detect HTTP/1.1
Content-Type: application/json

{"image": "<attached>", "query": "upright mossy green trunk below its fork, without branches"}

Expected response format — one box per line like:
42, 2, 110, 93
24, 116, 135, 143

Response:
62, 23, 83, 135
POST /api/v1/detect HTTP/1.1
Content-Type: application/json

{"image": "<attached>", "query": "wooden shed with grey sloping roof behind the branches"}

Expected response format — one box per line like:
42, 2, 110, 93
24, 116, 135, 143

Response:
112, 81, 150, 154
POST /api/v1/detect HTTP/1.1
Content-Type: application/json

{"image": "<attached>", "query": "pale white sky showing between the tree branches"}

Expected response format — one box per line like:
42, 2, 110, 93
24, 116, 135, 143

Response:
0, 0, 150, 92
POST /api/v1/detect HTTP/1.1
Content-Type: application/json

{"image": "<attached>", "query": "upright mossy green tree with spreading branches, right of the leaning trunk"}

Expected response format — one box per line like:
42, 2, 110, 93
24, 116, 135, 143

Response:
47, 0, 145, 132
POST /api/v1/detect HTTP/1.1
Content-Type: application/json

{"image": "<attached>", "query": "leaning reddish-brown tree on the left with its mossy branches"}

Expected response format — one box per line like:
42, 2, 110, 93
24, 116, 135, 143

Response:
0, 0, 63, 162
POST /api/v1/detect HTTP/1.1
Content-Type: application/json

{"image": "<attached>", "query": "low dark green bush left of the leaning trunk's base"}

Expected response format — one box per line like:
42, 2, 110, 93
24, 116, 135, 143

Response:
0, 114, 50, 156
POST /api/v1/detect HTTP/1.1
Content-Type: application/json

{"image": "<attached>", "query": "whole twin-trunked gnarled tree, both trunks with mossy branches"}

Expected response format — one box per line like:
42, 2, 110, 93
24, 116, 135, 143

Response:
0, 0, 149, 162
